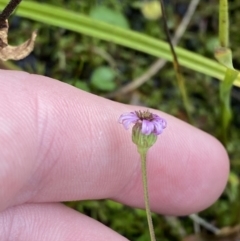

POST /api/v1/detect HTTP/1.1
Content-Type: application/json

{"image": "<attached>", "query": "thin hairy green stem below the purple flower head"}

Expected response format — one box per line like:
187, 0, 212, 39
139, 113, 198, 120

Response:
138, 148, 156, 241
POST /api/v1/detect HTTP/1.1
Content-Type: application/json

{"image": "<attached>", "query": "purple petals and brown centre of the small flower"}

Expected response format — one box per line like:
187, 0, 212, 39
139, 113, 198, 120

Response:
118, 110, 167, 135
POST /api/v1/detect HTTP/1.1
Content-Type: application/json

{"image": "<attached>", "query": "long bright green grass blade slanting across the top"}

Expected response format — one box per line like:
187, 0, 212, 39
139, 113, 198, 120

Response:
0, 0, 240, 87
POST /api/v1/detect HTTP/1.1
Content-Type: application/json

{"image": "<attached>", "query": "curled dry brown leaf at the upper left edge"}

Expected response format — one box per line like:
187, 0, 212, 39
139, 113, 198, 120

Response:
0, 20, 37, 61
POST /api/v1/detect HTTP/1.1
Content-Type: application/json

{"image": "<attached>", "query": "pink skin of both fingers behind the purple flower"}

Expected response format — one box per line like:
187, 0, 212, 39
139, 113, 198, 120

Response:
0, 70, 229, 241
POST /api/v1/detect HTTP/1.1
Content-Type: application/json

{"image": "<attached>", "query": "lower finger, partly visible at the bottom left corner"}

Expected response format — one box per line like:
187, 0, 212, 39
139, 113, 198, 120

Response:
0, 203, 127, 241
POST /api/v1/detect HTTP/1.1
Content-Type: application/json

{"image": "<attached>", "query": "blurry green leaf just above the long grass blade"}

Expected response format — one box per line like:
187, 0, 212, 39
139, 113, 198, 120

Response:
90, 6, 129, 29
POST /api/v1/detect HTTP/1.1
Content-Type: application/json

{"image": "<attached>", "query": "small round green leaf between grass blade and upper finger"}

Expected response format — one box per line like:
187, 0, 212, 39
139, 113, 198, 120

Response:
91, 66, 116, 91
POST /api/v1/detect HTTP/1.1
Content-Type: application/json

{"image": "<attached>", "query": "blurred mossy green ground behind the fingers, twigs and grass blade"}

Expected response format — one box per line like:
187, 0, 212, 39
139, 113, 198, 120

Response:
1, 0, 240, 241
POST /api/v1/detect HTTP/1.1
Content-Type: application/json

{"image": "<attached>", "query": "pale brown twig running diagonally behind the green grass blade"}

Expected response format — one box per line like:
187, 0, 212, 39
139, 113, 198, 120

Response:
106, 0, 200, 98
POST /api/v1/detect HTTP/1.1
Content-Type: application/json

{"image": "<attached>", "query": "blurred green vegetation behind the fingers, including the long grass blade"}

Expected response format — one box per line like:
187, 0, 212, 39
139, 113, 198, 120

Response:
0, 0, 240, 241
